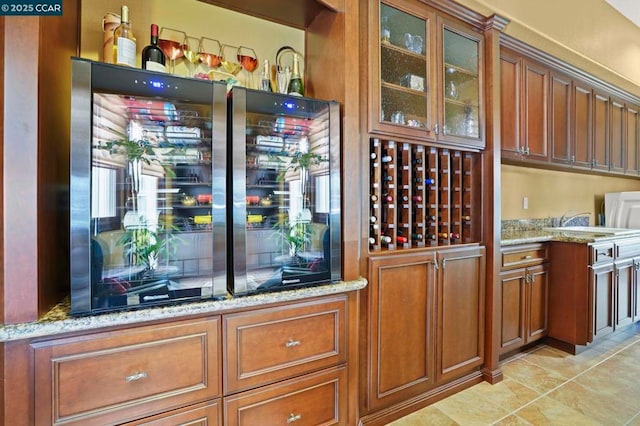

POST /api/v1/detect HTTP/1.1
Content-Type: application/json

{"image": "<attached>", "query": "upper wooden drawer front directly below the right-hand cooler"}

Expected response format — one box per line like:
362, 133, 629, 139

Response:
223, 295, 347, 394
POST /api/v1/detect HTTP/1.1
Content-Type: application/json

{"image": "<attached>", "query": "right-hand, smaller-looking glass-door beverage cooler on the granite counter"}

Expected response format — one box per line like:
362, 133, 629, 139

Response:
228, 87, 341, 295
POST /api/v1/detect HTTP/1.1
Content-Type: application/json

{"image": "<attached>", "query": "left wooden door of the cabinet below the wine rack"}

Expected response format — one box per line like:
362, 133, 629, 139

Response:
364, 252, 435, 411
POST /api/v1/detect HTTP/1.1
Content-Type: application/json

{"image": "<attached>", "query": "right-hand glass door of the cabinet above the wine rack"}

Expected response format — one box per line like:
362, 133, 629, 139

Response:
439, 23, 484, 145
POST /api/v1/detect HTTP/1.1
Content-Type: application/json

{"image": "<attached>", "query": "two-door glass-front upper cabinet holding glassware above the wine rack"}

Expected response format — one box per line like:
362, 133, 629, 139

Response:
368, 0, 484, 148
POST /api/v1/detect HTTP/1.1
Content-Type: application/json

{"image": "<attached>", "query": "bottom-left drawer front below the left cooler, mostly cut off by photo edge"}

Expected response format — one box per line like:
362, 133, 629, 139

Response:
126, 399, 222, 426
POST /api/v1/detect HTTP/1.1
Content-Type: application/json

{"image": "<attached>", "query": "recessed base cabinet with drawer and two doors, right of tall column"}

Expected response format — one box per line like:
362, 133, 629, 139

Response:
500, 244, 549, 354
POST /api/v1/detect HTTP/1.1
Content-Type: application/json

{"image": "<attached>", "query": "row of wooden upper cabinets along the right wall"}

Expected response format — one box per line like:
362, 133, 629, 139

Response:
500, 40, 640, 176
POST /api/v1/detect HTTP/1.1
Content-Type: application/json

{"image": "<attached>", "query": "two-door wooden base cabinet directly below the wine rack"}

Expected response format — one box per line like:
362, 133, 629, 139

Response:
361, 246, 485, 423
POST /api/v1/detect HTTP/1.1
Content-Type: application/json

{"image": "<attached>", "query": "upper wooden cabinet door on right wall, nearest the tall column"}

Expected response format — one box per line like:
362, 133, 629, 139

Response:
500, 51, 524, 159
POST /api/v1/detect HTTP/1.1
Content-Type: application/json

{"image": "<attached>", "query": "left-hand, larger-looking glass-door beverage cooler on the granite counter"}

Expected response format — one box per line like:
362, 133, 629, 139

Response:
70, 59, 227, 314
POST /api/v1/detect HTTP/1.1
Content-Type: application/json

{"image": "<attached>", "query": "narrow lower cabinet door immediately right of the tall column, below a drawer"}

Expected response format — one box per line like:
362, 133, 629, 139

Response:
500, 269, 525, 353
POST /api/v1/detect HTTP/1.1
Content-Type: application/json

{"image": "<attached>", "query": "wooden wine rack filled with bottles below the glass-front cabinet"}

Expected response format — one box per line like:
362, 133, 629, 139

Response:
369, 138, 482, 251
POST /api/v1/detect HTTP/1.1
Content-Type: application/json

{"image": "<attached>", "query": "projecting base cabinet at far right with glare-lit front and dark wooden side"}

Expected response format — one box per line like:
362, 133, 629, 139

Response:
549, 238, 640, 353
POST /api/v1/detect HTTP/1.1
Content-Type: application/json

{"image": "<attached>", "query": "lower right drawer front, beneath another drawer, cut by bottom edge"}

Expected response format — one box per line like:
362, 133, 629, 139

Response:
224, 367, 347, 426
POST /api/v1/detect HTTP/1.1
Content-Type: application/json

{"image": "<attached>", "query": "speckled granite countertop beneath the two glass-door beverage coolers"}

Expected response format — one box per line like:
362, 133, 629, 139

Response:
0, 278, 367, 342
